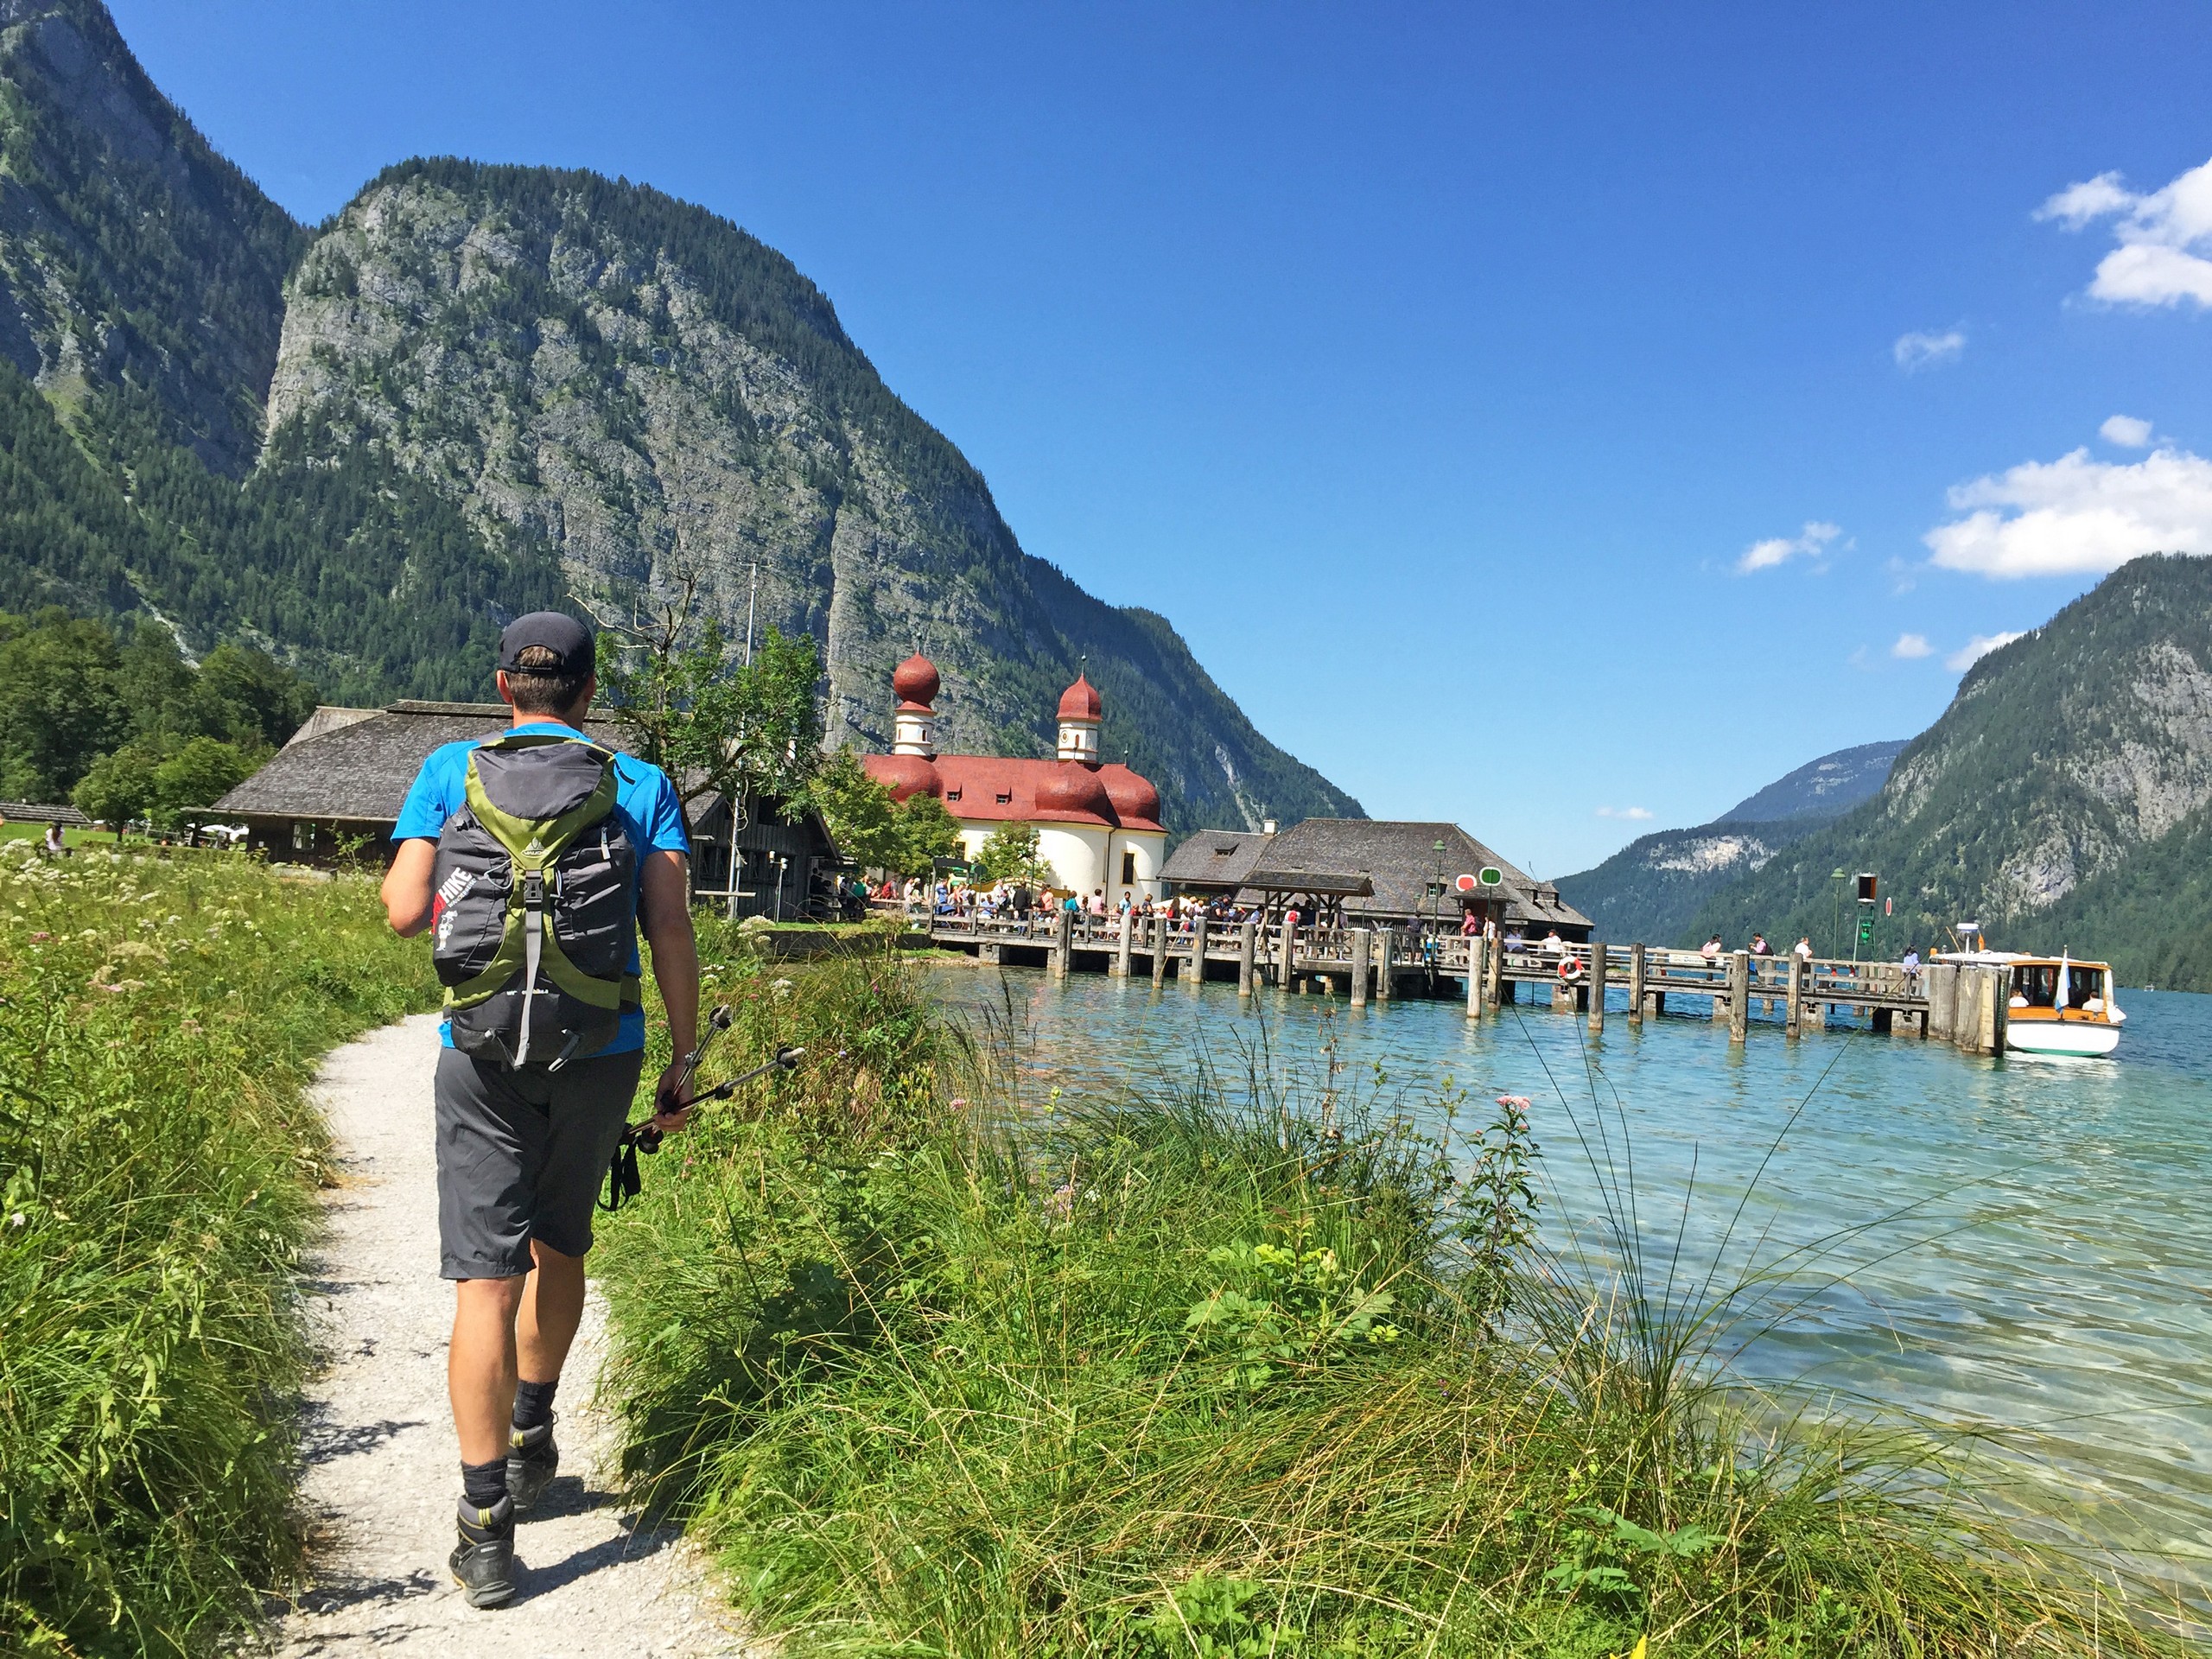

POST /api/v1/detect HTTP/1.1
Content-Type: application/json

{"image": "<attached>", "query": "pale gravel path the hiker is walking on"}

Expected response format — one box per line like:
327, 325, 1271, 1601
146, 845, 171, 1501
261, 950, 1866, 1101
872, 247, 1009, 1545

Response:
270, 1015, 754, 1659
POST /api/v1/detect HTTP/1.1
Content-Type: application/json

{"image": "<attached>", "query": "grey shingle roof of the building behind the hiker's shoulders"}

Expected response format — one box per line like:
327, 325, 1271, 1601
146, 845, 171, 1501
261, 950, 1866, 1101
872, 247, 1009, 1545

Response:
208, 702, 621, 825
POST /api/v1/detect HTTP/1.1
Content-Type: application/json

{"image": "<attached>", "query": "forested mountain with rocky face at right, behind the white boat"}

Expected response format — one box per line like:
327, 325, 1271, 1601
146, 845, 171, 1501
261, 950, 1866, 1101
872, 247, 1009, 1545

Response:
1692, 556, 2212, 988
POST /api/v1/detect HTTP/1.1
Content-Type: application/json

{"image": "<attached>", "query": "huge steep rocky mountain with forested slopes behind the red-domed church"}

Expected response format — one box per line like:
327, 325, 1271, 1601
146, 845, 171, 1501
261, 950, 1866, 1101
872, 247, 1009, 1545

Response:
0, 0, 1360, 830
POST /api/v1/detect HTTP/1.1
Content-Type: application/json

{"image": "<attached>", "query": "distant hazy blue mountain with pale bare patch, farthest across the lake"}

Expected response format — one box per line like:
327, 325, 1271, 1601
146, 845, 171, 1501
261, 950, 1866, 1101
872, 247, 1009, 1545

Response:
1560, 741, 1904, 944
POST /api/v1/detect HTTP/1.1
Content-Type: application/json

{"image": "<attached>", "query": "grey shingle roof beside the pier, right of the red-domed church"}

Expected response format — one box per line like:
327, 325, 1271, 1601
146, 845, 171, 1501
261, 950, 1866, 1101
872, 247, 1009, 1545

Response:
1248, 818, 1591, 927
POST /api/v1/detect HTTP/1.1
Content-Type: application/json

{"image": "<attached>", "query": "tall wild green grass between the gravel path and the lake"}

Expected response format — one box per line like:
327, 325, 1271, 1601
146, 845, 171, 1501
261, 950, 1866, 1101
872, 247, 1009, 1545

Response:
600, 953, 2194, 1659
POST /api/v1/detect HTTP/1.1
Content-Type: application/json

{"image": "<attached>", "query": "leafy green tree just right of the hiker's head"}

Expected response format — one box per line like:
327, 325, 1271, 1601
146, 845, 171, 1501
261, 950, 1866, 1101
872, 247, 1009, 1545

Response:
593, 570, 823, 805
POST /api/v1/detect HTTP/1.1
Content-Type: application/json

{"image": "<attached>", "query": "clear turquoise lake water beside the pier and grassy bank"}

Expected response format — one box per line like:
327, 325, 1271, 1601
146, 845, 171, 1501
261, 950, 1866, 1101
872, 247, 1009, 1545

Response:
944, 967, 2212, 1586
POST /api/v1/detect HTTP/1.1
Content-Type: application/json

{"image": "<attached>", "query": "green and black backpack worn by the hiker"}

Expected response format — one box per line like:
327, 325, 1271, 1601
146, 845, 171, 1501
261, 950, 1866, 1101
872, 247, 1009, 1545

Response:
431, 732, 639, 1071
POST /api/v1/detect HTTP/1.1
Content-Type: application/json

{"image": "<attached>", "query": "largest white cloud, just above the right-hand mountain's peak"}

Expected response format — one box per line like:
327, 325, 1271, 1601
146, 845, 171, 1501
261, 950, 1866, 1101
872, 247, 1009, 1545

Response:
1920, 449, 2212, 577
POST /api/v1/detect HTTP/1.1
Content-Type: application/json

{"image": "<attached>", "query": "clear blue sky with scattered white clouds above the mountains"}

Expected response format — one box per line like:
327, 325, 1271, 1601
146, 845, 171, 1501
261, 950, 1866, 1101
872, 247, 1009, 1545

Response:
115, 0, 2212, 876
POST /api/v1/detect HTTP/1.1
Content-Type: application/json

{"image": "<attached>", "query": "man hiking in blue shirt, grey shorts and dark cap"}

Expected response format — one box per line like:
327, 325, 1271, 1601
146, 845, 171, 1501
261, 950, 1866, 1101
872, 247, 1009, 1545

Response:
383, 611, 699, 1608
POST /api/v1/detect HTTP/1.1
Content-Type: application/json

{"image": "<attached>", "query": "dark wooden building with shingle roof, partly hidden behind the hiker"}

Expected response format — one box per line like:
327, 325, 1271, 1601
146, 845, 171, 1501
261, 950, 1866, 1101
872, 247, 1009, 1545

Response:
201, 702, 841, 920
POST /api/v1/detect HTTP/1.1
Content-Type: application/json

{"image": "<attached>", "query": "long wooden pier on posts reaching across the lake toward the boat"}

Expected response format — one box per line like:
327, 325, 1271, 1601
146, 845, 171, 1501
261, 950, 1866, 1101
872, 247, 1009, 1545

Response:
913, 912, 2011, 1053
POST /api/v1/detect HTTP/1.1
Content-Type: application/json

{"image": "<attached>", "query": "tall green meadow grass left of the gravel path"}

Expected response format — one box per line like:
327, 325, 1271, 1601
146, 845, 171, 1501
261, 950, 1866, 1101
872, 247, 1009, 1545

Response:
0, 845, 435, 1655
